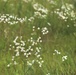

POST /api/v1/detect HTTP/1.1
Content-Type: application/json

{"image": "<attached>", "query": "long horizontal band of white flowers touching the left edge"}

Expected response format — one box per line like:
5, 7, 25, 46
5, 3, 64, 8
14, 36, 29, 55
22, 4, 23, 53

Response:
0, 14, 27, 25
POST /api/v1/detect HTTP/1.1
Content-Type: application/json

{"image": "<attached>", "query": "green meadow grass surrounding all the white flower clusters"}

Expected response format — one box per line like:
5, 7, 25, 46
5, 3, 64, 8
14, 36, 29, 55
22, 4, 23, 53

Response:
0, 0, 76, 75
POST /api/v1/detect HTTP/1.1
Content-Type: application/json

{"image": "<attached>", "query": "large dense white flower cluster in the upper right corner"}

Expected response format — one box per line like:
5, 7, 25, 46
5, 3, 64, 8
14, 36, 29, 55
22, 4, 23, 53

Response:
54, 3, 76, 21
